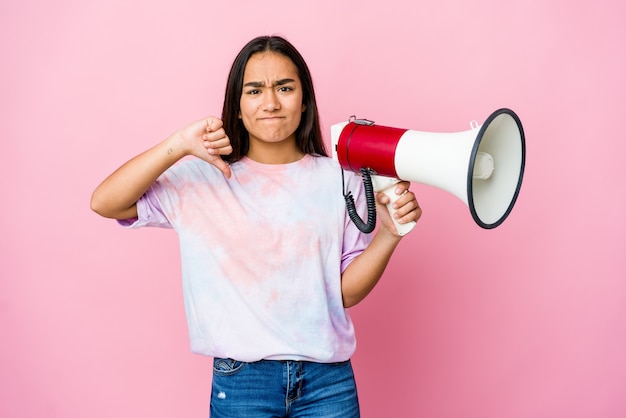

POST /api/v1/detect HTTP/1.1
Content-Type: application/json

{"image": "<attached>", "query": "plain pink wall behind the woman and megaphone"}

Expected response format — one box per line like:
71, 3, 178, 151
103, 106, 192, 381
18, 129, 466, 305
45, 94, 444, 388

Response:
0, 0, 626, 418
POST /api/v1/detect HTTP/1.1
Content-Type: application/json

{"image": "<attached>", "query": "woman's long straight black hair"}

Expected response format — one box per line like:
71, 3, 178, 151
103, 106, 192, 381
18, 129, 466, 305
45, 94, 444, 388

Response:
222, 36, 328, 163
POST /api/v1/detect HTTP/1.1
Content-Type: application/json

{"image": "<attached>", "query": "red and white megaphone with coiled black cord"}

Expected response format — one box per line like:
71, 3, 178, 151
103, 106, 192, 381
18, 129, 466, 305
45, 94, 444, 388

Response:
331, 108, 526, 235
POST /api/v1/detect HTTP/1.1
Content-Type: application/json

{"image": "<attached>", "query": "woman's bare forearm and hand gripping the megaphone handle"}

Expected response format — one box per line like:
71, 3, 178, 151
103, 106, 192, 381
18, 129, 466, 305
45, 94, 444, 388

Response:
341, 181, 422, 308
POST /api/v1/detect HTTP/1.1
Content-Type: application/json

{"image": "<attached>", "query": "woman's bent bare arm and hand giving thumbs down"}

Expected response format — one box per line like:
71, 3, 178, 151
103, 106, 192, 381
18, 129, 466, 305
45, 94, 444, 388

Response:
91, 117, 232, 219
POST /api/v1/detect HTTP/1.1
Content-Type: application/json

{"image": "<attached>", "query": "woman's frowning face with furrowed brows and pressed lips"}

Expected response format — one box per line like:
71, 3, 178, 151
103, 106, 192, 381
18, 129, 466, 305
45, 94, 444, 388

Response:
239, 52, 305, 156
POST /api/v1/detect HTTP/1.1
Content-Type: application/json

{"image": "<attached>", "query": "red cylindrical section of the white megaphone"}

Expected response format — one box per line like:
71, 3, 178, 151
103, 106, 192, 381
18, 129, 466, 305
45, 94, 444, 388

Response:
337, 122, 408, 177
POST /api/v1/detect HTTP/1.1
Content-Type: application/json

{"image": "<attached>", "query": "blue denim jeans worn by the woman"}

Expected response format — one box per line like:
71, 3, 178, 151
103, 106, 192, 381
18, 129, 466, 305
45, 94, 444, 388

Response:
211, 358, 360, 418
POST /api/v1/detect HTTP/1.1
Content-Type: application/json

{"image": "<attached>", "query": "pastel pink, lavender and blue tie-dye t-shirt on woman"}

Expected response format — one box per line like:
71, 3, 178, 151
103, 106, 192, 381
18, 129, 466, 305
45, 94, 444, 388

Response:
121, 155, 371, 362
